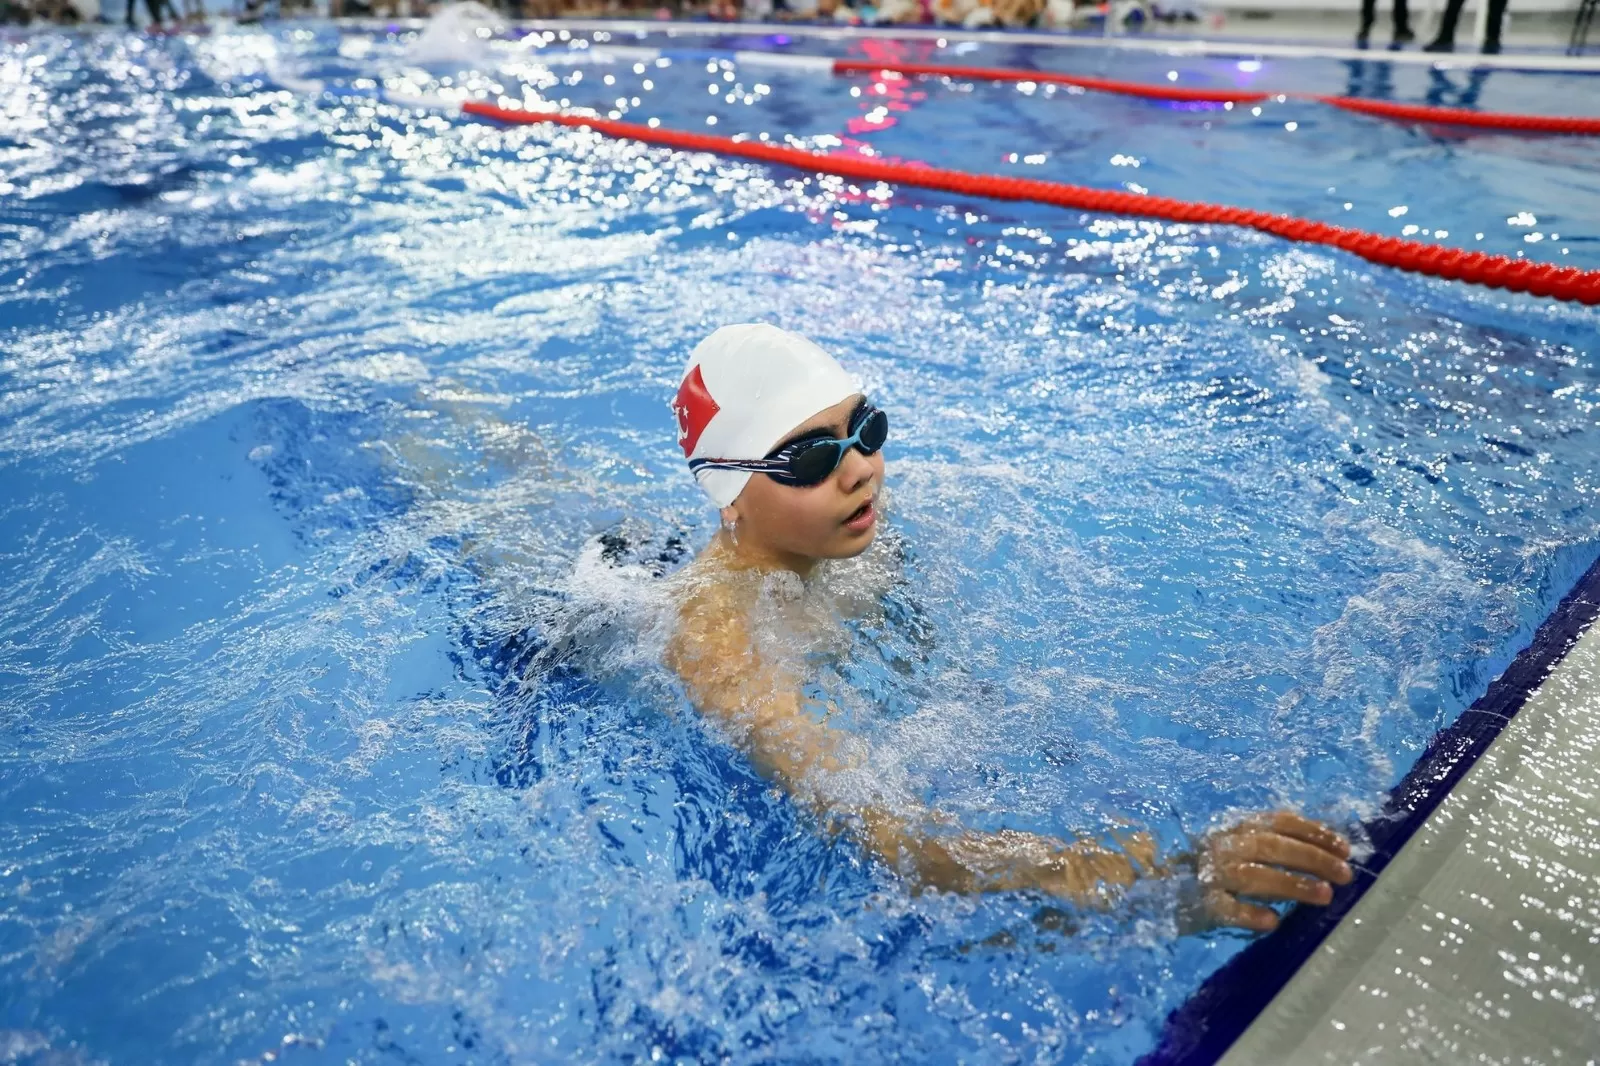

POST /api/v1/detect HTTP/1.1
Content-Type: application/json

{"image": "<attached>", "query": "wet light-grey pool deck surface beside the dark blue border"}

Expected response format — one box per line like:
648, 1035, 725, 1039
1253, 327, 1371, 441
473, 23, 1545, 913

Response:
1221, 589, 1600, 1066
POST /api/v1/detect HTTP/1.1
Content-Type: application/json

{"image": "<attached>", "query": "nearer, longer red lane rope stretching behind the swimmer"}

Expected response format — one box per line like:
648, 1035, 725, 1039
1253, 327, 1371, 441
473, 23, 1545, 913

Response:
461, 101, 1600, 304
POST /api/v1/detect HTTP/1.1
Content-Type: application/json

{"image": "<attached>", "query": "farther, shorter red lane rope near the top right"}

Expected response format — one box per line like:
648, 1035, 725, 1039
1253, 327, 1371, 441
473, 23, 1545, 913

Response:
834, 59, 1600, 136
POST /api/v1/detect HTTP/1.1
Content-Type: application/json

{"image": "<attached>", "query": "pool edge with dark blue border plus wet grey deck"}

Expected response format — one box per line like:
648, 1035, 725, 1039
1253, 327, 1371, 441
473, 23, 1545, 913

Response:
1139, 550, 1600, 1066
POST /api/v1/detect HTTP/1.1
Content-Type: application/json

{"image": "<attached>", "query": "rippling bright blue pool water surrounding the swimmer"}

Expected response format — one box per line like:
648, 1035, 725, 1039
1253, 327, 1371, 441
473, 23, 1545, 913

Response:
0, 22, 1600, 1066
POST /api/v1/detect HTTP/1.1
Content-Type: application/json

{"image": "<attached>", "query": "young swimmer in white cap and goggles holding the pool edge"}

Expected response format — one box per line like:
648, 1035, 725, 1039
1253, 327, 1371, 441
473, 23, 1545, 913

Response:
667, 325, 1352, 932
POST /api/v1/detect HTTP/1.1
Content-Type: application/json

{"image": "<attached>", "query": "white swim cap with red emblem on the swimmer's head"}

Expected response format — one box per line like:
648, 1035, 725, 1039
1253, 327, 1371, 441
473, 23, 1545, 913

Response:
672, 322, 861, 507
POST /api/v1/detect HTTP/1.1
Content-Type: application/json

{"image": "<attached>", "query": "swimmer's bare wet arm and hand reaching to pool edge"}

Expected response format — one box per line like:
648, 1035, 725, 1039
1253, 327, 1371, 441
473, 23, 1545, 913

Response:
666, 598, 1350, 932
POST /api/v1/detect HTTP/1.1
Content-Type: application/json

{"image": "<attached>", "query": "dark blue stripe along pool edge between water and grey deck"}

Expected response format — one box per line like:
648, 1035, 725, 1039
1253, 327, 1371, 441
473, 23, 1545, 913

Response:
1138, 547, 1600, 1066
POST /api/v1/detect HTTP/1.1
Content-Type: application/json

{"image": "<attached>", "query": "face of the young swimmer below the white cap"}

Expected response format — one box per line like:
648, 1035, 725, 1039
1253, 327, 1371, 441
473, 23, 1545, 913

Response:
723, 395, 883, 565
